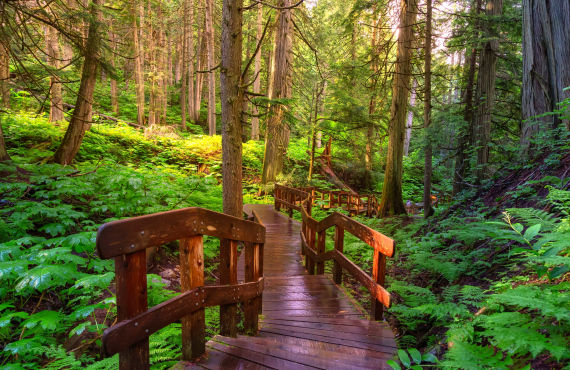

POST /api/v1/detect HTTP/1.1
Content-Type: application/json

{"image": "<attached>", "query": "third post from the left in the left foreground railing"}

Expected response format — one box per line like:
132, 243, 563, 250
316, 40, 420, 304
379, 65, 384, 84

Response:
219, 239, 237, 337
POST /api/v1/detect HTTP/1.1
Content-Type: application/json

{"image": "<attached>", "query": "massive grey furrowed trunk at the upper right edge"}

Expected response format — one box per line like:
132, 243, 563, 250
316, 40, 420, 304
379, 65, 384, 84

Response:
521, 0, 570, 155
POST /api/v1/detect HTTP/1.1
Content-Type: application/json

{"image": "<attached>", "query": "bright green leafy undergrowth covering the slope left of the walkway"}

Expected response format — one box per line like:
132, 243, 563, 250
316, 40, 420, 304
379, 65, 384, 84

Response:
0, 115, 263, 369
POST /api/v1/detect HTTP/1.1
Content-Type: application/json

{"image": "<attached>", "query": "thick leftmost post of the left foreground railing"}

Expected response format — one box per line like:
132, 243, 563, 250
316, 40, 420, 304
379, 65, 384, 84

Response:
115, 249, 146, 370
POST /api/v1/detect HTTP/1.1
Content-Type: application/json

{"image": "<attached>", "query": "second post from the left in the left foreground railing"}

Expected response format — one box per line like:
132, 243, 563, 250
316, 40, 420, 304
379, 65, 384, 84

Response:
180, 235, 206, 361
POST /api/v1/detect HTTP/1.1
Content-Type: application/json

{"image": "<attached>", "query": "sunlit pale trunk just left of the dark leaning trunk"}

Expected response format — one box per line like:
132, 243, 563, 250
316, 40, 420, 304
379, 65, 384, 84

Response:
44, 26, 64, 122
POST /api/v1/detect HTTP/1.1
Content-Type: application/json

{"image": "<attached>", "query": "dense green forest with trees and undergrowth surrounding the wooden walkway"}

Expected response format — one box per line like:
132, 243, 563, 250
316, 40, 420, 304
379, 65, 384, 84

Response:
0, 0, 570, 369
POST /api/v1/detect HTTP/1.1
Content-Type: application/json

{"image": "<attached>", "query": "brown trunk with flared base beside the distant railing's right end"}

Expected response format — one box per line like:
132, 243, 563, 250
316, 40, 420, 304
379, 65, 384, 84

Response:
379, 0, 417, 216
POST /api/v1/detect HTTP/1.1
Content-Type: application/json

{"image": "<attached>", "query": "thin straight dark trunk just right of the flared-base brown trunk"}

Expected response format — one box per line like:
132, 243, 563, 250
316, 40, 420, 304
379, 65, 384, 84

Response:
424, 0, 433, 218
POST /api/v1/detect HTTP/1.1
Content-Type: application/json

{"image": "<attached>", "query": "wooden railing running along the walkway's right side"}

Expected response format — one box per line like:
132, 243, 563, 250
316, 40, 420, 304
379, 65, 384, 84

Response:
274, 185, 395, 320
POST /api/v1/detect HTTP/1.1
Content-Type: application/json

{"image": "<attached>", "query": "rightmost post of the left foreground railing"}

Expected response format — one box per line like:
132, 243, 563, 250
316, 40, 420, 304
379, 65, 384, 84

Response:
243, 243, 261, 335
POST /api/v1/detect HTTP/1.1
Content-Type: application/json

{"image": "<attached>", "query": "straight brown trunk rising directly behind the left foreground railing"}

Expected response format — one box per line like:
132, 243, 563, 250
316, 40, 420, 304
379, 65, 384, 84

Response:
220, 0, 243, 217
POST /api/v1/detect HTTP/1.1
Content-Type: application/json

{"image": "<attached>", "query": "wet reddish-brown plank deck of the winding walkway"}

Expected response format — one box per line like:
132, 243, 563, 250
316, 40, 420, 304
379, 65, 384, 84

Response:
185, 205, 396, 369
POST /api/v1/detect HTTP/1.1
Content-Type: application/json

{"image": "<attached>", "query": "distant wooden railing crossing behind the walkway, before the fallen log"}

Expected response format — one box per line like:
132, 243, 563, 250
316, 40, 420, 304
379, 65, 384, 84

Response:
299, 186, 379, 217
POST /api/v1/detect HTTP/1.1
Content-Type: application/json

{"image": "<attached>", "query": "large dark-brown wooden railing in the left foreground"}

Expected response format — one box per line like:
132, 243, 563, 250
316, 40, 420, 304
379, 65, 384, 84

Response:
96, 208, 265, 369
